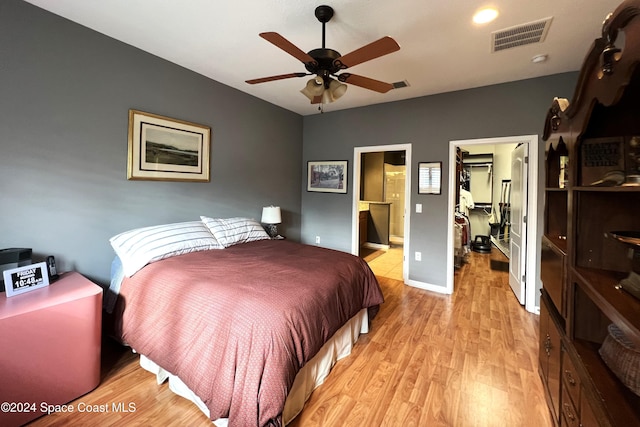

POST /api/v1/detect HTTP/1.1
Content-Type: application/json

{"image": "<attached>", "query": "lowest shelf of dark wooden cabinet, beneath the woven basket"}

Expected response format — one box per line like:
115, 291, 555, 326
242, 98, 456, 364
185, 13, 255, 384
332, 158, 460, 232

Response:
573, 340, 640, 426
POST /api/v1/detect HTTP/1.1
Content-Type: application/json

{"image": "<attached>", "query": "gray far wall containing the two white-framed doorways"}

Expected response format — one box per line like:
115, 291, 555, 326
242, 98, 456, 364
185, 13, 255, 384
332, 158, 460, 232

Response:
301, 73, 577, 287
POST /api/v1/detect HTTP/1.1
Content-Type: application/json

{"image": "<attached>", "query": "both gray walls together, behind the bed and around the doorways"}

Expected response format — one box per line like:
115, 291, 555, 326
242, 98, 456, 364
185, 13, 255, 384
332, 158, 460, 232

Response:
0, 0, 577, 298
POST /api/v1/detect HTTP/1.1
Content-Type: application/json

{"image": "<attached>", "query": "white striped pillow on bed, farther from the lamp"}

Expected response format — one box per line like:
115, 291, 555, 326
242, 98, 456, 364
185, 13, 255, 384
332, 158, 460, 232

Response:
109, 221, 224, 277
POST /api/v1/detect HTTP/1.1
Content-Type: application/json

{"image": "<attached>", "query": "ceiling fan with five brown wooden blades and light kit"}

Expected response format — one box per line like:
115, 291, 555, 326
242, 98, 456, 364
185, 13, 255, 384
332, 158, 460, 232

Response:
246, 6, 400, 104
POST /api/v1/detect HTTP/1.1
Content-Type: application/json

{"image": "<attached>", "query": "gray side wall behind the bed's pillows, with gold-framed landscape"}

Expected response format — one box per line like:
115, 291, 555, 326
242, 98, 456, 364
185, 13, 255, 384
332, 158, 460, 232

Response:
0, 0, 303, 283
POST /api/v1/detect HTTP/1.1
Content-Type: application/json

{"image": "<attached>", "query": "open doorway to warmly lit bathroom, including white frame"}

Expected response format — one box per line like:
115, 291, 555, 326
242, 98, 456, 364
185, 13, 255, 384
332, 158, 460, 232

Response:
352, 144, 411, 281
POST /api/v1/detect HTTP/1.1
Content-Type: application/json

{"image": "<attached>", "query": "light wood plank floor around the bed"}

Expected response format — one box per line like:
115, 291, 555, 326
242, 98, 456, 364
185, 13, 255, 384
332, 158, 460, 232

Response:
31, 253, 551, 427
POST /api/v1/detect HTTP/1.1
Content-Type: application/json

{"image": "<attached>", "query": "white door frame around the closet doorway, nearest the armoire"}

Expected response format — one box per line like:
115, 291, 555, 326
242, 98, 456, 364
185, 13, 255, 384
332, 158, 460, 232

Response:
446, 135, 540, 313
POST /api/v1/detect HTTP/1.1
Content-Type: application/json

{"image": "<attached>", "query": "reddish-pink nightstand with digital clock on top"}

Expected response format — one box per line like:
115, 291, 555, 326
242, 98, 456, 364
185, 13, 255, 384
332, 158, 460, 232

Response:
0, 272, 102, 426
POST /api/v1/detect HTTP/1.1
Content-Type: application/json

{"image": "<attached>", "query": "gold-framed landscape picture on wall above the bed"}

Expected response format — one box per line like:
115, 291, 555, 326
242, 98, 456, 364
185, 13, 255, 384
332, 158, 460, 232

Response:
127, 110, 211, 182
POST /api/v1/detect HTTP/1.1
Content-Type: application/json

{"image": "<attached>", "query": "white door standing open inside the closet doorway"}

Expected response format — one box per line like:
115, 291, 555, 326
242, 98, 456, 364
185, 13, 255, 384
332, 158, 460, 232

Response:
509, 144, 529, 305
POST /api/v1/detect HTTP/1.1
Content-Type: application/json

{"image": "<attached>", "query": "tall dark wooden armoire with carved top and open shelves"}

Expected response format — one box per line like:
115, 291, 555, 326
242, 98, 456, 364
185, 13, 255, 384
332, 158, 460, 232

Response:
539, 0, 640, 427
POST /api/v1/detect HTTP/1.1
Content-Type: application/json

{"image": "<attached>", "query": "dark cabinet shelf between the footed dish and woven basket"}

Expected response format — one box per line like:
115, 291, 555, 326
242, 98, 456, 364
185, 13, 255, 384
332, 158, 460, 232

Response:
573, 267, 640, 343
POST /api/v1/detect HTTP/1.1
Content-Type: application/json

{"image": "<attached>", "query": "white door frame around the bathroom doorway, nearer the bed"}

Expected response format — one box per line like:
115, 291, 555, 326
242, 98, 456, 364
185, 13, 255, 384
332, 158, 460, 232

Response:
351, 144, 411, 283
